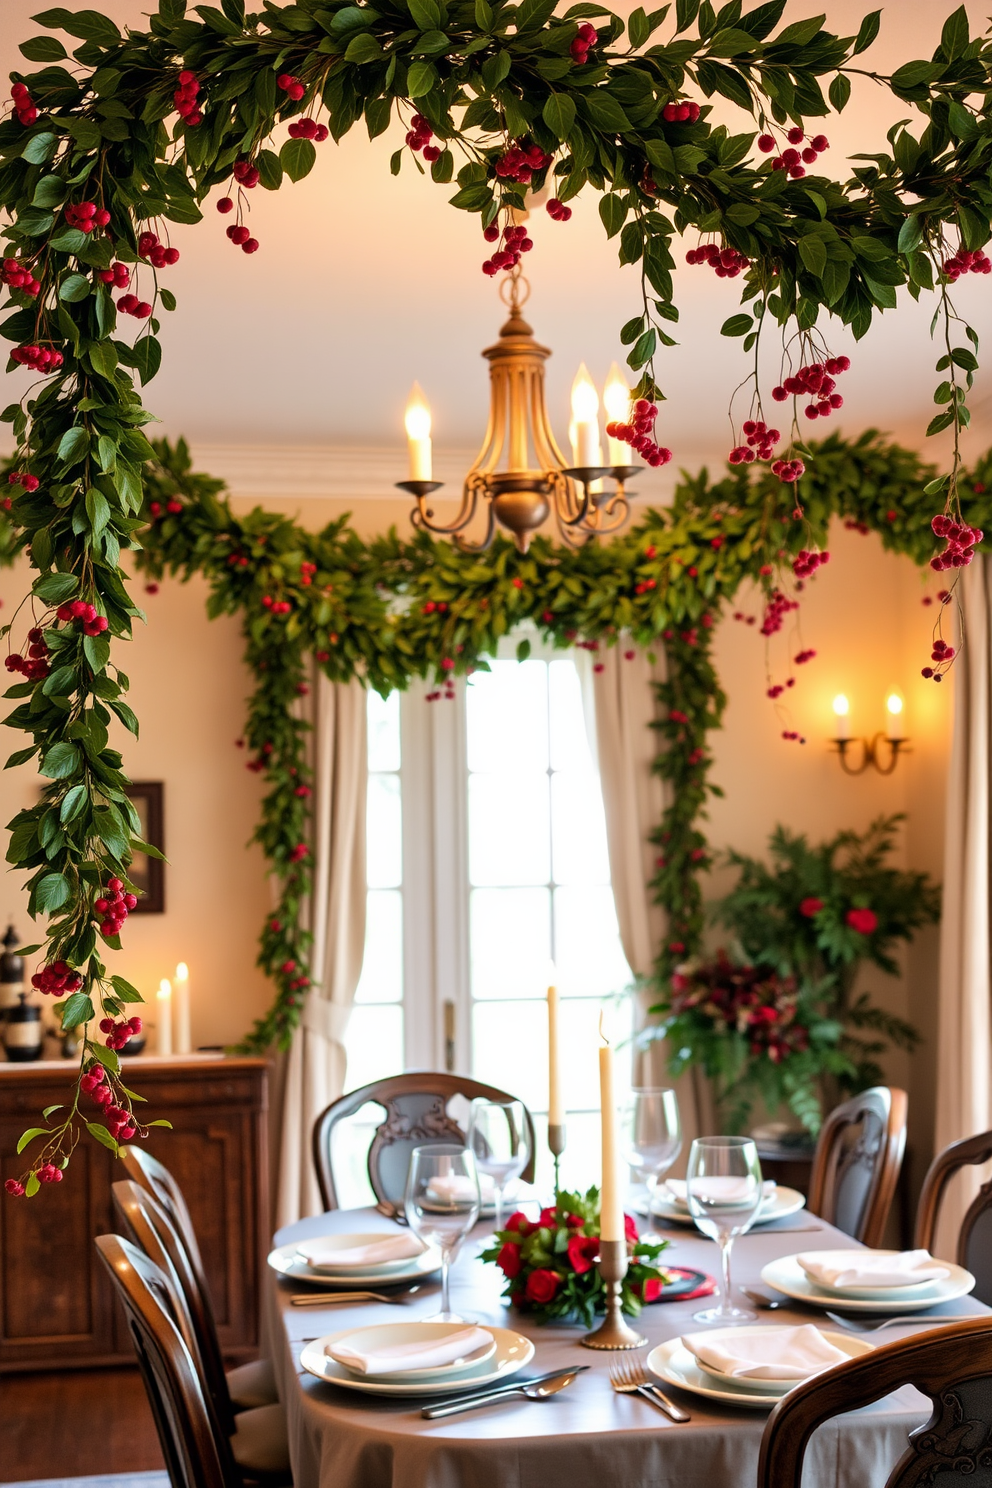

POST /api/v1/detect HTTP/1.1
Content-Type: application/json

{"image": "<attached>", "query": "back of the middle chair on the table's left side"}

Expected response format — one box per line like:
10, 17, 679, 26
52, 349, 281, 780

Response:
110, 1178, 235, 1436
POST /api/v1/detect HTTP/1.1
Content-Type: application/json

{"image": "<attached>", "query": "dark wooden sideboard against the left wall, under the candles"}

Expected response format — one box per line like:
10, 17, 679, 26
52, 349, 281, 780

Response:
0, 1055, 269, 1373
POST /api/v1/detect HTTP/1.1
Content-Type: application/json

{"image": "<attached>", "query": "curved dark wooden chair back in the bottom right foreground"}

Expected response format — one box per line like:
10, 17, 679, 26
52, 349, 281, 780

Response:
757, 1317, 992, 1488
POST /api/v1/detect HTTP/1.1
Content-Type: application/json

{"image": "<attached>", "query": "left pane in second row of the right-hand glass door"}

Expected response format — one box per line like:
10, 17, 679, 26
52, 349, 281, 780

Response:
468, 771, 550, 885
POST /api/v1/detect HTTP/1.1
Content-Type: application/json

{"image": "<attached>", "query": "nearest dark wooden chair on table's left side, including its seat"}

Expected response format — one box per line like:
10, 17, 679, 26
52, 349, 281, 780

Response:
95, 1235, 293, 1488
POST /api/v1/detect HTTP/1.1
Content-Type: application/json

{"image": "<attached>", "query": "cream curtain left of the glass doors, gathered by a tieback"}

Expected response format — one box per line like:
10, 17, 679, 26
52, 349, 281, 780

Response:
275, 673, 369, 1226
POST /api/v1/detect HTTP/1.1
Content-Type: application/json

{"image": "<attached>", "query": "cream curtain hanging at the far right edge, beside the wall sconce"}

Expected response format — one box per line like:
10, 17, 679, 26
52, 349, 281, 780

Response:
935, 557, 992, 1256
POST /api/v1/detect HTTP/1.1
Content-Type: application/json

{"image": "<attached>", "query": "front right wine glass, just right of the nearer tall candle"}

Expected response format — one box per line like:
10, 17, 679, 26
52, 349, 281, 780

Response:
686, 1137, 761, 1323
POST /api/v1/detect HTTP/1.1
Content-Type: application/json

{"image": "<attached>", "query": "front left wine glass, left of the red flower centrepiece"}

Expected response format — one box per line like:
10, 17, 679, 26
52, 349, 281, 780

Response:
403, 1143, 482, 1323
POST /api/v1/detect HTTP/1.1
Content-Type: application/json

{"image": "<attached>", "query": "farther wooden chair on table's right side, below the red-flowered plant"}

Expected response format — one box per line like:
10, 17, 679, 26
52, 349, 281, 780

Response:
809, 1085, 907, 1245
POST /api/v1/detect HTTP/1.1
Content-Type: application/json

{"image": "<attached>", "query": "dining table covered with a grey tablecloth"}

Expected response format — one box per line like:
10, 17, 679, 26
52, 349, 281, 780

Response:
265, 1208, 992, 1488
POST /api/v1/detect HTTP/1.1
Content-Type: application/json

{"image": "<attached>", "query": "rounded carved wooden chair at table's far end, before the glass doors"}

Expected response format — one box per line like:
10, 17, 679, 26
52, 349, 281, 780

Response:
312, 1070, 535, 1210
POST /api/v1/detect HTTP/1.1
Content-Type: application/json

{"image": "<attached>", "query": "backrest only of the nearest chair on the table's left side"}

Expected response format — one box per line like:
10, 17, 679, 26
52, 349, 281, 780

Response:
95, 1235, 242, 1488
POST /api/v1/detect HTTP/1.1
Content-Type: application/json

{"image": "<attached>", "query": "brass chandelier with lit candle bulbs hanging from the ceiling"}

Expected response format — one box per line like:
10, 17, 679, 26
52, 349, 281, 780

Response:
397, 266, 641, 552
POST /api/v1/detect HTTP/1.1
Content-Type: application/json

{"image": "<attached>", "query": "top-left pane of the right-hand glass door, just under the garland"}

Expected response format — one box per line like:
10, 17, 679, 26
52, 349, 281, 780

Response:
466, 661, 547, 775
